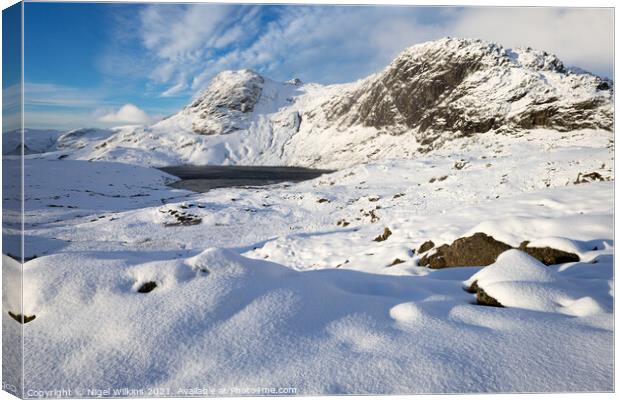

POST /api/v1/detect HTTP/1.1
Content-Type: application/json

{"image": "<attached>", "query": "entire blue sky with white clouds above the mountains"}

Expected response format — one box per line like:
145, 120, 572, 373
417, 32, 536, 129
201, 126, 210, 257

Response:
12, 3, 613, 129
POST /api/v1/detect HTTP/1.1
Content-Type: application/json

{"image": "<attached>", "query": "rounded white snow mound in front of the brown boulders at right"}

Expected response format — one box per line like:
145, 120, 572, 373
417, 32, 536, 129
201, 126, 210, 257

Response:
464, 250, 609, 316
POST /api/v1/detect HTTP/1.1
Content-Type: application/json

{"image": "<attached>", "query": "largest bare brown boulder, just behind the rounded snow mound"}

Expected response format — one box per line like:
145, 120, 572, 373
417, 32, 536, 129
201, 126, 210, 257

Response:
419, 232, 512, 268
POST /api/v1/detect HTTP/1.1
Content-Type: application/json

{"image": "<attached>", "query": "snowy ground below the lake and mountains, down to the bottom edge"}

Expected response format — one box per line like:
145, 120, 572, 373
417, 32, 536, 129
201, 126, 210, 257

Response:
3, 131, 614, 397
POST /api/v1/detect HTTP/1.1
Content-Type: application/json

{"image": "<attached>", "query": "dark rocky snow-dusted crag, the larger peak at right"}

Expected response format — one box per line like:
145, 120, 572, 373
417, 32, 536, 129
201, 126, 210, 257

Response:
310, 38, 613, 148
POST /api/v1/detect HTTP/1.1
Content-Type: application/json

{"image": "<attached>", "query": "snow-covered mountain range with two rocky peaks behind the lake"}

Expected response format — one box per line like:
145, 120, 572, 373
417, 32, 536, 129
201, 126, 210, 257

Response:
42, 38, 613, 167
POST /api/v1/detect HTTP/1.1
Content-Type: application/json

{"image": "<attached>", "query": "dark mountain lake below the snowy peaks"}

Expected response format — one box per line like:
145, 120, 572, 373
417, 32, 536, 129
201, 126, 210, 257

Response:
160, 165, 333, 192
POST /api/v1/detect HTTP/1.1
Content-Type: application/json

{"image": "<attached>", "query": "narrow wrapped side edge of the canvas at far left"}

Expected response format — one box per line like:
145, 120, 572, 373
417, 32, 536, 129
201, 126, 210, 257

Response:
2, 2, 24, 397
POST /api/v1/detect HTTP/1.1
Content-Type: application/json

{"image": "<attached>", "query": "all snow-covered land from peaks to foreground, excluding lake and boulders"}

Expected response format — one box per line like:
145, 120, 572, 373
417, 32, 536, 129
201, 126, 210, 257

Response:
2, 39, 615, 397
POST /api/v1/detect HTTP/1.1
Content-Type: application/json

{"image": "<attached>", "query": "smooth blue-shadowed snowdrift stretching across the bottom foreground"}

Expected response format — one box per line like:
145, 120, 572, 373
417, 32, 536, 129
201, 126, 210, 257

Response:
20, 242, 611, 394
